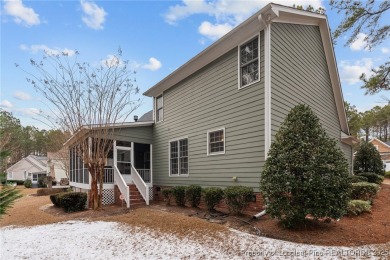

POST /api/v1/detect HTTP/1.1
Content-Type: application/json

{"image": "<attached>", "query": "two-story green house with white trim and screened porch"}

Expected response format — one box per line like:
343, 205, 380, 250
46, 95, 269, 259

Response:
66, 4, 353, 209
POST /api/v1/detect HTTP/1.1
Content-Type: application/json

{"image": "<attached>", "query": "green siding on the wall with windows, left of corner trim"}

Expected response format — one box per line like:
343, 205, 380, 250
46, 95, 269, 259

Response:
153, 32, 264, 191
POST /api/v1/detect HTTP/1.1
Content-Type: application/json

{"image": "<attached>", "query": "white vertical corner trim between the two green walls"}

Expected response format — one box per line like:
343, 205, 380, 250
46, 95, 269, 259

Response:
264, 23, 271, 159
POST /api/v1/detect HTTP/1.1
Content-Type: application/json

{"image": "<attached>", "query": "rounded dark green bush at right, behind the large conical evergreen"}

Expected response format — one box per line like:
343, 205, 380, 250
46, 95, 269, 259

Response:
353, 141, 384, 175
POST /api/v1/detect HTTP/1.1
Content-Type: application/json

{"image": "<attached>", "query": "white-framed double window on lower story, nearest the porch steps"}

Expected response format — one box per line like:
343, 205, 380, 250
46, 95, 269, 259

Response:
169, 138, 188, 176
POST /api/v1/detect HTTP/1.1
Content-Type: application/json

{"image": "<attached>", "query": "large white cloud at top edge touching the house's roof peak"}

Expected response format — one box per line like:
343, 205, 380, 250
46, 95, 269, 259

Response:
164, 0, 322, 40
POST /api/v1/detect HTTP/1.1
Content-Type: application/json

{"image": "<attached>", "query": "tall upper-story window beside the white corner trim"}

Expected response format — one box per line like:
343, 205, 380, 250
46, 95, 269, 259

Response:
239, 36, 260, 88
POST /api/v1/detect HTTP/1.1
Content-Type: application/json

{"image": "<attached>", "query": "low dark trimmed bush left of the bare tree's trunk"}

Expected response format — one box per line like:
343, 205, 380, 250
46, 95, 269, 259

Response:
53, 192, 87, 212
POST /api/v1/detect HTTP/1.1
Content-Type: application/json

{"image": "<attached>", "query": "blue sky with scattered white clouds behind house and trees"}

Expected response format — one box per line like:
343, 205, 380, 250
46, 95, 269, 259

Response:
0, 0, 390, 128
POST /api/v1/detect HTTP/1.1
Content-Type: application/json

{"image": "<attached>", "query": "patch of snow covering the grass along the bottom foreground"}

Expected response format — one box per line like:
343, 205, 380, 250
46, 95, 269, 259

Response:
0, 221, 382, 260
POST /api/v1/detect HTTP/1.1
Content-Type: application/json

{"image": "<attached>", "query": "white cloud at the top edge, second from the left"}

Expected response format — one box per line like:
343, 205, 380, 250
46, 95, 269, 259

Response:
80, 0, 107, 30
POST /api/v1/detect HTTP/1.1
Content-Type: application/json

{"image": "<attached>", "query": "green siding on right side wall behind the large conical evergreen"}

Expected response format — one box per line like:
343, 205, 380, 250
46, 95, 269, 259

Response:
271, 23, 351, 172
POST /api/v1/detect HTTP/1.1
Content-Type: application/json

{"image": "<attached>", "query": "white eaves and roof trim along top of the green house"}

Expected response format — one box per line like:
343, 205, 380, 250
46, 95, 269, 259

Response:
144, 3, 349, 134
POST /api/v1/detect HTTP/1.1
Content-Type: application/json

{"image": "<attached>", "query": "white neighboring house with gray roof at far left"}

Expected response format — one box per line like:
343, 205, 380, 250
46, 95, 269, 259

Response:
7, 155, 66, 184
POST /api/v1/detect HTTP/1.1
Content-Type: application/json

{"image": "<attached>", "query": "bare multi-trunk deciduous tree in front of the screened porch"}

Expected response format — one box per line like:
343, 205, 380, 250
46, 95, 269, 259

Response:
17, 49, 140, 209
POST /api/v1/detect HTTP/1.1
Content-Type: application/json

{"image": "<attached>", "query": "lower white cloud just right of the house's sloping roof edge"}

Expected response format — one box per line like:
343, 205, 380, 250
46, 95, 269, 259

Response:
340, 59, 373, 85
